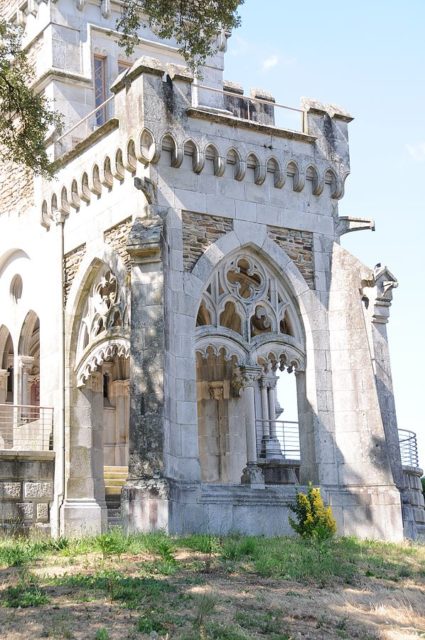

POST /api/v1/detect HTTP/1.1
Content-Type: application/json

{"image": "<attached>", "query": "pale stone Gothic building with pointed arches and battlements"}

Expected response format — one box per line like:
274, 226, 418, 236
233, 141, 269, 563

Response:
0, 0, 425, 540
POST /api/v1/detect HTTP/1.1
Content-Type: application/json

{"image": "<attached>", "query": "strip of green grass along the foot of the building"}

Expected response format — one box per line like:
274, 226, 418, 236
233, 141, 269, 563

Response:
0, 529, 425, 584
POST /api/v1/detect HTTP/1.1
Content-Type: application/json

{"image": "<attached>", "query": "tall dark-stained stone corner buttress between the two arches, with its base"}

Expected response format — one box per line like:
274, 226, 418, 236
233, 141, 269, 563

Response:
122, 206, 169, 532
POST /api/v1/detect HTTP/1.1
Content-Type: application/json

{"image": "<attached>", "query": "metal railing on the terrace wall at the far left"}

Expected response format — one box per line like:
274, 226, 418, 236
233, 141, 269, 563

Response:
0, 404, 53, 451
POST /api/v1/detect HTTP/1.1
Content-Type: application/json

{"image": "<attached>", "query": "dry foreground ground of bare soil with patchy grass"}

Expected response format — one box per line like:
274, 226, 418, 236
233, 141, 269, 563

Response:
0, 551, 425, 640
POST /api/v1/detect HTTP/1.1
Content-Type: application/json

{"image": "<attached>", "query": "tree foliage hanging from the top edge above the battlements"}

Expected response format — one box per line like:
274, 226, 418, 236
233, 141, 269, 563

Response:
117, 0, 244, 68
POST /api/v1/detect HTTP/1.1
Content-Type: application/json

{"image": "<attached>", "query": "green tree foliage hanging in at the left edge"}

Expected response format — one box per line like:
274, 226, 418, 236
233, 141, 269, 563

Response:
0, 20, 60, 176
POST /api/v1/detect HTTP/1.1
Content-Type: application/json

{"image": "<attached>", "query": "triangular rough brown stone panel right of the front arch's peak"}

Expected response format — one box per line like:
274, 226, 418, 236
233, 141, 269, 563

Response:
267, 226, 314, 289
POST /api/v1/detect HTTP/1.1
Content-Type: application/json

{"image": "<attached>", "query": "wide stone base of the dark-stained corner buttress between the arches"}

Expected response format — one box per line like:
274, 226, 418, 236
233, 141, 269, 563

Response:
121, 478, 170, 533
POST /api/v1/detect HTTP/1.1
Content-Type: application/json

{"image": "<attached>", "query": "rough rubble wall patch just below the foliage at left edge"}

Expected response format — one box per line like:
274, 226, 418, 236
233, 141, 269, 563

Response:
0, 162, 34, 215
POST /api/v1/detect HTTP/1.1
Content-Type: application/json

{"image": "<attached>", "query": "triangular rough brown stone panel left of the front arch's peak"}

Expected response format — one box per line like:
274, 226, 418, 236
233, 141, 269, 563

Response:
182, 211, 233, 271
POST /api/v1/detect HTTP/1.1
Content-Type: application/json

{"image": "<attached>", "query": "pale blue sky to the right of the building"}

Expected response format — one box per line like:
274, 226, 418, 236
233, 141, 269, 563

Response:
225, 0, 425, 465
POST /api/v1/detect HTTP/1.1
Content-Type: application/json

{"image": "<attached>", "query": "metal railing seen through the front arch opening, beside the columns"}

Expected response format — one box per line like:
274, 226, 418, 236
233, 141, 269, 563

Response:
256, 420, 301, 460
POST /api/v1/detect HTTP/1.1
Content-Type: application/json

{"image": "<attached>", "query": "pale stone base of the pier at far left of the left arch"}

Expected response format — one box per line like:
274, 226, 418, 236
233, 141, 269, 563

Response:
61, 498, 108, 538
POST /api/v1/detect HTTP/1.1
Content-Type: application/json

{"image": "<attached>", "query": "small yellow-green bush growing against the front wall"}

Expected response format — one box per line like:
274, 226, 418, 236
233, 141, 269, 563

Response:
289, 482, 336, 541
